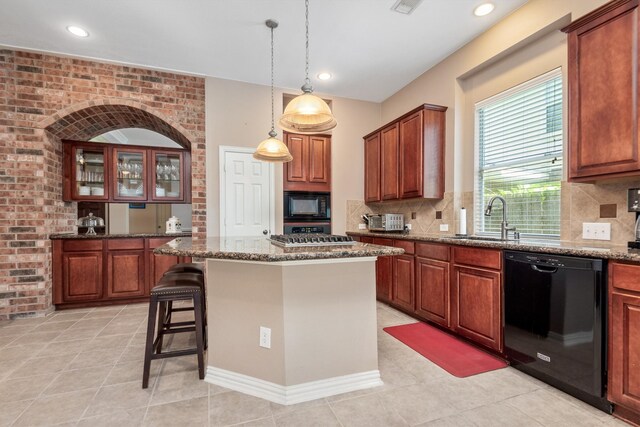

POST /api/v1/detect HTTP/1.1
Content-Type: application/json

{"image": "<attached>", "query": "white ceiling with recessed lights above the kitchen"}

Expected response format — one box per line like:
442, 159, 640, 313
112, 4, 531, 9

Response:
0, 0, 527, 102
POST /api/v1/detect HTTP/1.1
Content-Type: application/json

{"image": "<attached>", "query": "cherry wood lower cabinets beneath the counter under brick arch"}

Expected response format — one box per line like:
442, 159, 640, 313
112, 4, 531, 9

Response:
52, 237, 191, 308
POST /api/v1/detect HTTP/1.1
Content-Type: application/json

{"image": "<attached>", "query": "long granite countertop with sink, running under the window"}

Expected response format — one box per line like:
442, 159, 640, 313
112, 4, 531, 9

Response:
347, 231, 640, 262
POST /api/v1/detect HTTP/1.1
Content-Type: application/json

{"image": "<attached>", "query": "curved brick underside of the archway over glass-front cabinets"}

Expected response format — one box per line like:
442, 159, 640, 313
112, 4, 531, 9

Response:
40, 101, 191, 149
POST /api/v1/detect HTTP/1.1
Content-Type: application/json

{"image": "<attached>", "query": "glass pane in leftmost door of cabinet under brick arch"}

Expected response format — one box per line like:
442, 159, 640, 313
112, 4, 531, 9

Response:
73, 147, 105, 198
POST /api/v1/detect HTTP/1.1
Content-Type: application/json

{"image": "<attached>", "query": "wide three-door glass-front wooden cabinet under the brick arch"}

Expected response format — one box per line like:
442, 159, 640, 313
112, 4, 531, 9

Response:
63, 141, 191, 203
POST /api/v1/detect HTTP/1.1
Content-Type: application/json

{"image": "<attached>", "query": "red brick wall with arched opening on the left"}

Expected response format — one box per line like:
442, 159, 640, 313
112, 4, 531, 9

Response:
0, 50, 206, 319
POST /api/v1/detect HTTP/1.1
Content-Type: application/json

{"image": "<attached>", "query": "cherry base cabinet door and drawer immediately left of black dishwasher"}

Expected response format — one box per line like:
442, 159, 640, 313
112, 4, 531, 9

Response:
451, 246, 503, 352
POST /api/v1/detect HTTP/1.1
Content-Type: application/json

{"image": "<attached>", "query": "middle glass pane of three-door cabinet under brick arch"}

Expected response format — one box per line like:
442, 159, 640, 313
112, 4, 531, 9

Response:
114, 150, 147, 199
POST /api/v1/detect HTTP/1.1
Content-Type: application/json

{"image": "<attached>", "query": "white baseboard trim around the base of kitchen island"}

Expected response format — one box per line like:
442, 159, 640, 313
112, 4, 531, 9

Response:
204, 366, 383, 405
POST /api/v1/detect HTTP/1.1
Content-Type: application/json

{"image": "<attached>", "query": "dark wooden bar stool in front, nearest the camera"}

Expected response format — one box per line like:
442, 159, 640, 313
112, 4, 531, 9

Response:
142, 273, 206, 388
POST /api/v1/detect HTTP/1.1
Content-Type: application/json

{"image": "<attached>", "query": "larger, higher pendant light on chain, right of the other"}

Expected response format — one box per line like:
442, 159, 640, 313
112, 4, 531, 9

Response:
279, 0, 338, 133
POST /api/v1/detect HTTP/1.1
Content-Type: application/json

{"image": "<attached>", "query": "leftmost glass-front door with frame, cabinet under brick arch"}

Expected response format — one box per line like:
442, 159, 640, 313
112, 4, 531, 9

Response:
69, 145, 109, 200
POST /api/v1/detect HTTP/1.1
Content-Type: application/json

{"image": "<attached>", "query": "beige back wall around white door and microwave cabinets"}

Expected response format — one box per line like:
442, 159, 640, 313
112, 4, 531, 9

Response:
206, 77, 380, 236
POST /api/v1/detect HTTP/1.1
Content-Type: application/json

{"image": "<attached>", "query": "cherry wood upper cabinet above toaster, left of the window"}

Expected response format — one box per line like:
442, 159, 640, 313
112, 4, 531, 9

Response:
364, 104, 447, 202
